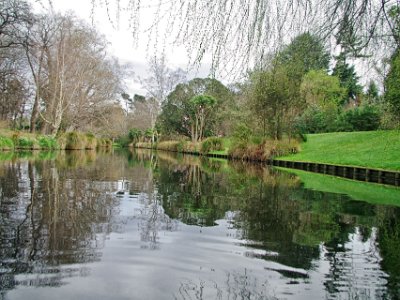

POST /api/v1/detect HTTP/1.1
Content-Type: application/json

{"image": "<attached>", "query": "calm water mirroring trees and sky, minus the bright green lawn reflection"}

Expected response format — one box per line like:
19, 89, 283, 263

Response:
0, 151, 400, 299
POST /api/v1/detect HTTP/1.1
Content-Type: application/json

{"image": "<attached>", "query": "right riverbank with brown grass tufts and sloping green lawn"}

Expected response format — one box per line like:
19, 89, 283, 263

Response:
136, 130, 400, 171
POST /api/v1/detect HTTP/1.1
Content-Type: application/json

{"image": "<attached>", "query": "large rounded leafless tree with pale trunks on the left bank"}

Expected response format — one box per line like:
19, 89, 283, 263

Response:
25, 15, 123, 134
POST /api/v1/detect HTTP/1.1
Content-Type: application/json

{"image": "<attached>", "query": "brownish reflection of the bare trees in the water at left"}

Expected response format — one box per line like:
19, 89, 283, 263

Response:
0, 152, 118, 291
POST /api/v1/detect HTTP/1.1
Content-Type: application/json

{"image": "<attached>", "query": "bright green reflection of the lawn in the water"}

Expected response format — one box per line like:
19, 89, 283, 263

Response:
277, 168, 400, 206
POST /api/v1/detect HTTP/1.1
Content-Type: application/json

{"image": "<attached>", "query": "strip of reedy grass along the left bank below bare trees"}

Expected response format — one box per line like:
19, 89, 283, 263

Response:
0, 129, 112, 151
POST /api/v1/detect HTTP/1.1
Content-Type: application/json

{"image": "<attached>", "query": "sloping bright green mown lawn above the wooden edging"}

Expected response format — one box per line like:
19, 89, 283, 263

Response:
279, 130, 400, 170
